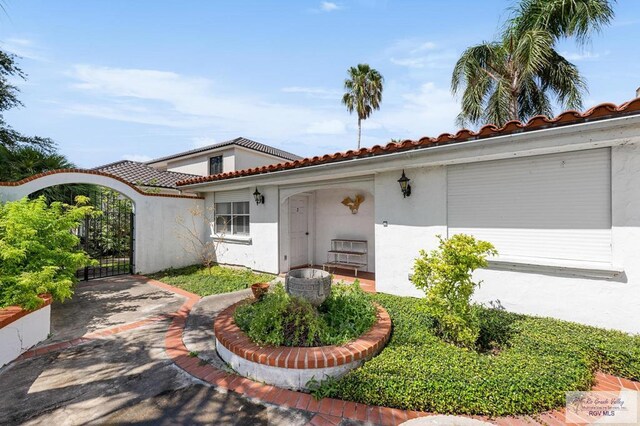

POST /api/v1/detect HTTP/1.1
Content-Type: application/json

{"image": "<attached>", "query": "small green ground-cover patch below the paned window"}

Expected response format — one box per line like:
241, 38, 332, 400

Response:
149, 265, 275, 296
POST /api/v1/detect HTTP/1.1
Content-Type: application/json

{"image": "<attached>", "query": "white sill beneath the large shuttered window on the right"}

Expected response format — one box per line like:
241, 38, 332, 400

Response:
485, 257, 624, 280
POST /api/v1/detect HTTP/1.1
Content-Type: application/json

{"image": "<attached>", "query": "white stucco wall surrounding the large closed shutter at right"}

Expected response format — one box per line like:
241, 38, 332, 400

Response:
375, 148, 640, 333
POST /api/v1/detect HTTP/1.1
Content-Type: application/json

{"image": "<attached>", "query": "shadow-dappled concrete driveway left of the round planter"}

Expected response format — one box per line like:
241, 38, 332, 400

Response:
0, 276, 306, 425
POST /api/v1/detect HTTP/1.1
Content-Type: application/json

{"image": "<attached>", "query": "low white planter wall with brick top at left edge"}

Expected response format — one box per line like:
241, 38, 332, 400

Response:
0, 295, 51, 367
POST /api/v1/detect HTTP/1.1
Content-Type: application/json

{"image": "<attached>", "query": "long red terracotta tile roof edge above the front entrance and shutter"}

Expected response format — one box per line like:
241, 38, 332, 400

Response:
177, 98, 640, 186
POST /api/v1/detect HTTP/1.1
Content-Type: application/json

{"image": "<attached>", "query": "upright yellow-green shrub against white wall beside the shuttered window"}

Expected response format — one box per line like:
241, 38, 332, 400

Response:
412, 234, 497, 348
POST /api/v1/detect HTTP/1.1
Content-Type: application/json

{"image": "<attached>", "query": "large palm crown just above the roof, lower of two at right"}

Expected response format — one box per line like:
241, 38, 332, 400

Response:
451, 30, 586, 126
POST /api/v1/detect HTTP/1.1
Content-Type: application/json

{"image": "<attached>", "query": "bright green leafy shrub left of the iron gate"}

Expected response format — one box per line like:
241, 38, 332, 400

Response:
0, 197, 97, 309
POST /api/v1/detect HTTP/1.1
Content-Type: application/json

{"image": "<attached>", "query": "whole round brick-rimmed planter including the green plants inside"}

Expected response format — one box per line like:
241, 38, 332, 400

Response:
214, 284, 391, 390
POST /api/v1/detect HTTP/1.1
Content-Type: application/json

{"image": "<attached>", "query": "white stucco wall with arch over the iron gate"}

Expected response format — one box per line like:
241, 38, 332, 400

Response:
0, 173, 204, 274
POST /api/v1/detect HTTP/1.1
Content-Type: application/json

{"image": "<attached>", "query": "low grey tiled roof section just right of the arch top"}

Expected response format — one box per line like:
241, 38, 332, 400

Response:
93, 160, 198, 189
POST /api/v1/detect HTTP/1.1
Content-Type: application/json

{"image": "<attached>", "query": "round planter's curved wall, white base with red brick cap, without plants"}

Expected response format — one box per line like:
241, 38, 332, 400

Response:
214, 302, 391, 390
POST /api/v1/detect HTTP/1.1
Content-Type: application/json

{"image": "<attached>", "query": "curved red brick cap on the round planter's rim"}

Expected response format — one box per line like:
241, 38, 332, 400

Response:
214, 300, 391, 369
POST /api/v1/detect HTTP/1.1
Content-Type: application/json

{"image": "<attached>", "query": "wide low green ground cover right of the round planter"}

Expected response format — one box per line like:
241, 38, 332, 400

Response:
325, 294, 640, 416
